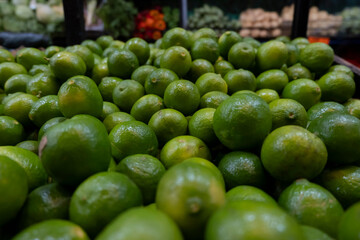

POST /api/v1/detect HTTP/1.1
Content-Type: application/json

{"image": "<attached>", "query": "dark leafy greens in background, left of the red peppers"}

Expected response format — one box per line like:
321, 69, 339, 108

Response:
97, 0, 137, 38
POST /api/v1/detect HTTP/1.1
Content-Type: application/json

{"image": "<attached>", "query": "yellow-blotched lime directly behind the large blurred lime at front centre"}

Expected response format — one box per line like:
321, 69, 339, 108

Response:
160, 135, 211, 168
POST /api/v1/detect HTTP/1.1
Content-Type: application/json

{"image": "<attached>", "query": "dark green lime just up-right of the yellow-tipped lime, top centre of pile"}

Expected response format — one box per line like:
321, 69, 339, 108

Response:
191, 38, 220, 64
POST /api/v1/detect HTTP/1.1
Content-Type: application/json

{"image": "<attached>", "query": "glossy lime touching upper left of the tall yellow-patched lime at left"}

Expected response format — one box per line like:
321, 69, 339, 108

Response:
26, 73, 60, 98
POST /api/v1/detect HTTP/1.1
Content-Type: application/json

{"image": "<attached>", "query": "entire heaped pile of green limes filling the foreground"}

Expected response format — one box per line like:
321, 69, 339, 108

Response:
0, 28, 360, 240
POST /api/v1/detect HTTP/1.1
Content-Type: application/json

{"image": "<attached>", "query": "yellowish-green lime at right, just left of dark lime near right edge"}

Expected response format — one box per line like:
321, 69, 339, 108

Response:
281, 78, 322, 110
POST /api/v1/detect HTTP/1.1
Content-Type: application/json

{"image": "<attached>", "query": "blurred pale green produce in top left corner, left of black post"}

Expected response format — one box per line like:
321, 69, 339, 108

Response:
0, 0, 64, 34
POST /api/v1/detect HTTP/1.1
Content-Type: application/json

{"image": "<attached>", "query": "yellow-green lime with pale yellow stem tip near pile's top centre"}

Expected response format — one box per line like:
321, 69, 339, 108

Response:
160, 46, 191, 77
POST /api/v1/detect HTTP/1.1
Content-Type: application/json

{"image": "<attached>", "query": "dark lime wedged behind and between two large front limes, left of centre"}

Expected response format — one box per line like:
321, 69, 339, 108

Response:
116, 154, 165, 205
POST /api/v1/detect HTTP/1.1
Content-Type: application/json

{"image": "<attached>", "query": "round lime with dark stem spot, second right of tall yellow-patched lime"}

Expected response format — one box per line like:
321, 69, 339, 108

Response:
113, 80, 145, 112
